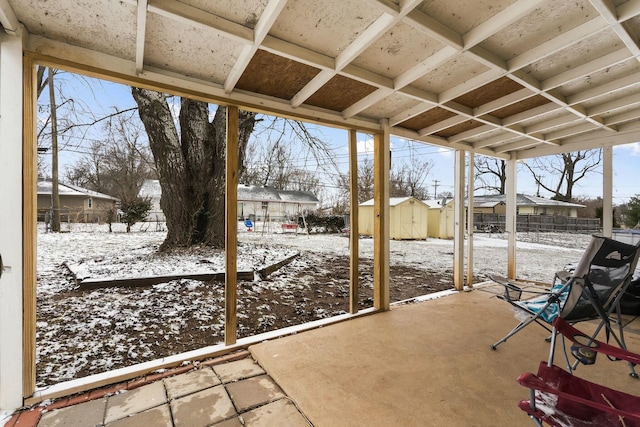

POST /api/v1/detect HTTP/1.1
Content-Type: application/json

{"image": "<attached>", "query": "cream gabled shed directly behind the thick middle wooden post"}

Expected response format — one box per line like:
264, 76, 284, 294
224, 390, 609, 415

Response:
358, 197, 428, 240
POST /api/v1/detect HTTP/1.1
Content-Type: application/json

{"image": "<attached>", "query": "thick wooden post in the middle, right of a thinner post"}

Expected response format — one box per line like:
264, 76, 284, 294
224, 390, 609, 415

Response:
373, 120, 391, 310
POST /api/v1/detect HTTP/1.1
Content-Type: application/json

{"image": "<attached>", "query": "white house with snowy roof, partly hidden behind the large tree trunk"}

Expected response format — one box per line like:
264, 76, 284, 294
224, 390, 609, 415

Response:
139, 179, 320, 221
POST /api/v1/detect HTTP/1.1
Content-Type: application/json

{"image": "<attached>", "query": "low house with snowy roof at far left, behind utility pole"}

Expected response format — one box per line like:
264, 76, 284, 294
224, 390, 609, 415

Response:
38, 180, 118, 222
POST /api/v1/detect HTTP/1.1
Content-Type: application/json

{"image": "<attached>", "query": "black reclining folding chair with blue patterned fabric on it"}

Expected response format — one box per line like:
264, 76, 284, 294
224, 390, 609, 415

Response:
491, 236, 640, 376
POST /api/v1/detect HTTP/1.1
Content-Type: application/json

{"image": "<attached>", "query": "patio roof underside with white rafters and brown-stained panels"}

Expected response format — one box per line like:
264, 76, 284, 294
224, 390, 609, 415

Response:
0, 0, 640, 159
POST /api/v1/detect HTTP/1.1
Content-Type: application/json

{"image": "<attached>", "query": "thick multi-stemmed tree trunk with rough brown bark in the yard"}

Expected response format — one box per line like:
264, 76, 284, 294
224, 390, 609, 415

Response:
132, 88, 256, 250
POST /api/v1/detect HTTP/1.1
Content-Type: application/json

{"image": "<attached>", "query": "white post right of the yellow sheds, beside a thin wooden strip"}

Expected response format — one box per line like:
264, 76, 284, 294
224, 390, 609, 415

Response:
453, 150, 465, 291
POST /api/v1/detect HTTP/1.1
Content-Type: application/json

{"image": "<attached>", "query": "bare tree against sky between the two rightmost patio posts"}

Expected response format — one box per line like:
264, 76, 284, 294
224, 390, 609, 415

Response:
524, 149, 602, 202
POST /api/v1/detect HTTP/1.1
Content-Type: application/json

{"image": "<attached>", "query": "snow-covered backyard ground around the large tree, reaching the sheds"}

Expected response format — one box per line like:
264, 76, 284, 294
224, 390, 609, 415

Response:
36, 224, 590, 387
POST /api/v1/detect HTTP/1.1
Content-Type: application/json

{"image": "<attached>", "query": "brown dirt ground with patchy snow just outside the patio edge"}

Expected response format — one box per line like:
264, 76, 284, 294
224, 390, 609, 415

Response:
37, 253, 453, 386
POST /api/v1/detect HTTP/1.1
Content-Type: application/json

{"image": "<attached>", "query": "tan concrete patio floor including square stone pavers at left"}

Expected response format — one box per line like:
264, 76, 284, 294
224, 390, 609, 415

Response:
7, 286, 640, 427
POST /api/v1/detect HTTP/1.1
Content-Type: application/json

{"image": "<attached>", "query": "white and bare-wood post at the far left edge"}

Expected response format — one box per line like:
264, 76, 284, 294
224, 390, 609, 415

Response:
0, 31, 26, 413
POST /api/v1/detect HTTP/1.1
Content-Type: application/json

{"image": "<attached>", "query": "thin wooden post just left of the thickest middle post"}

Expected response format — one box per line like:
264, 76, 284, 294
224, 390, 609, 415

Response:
349, 129, 360, 314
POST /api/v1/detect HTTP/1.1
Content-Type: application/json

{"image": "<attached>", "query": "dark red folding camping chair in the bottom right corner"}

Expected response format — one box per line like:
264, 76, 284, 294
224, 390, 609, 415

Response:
518, 317, 640, 427
